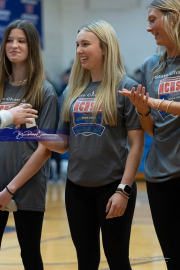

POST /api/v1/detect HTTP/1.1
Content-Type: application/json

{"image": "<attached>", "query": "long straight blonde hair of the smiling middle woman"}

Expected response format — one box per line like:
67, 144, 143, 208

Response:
63, 20, 125, 126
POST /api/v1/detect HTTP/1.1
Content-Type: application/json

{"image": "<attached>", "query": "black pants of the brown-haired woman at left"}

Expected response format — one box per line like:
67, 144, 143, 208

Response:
0, 210, 44, 270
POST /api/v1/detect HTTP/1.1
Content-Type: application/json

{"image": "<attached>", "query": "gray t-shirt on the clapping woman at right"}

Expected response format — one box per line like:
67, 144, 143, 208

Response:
141, 55, 180, 182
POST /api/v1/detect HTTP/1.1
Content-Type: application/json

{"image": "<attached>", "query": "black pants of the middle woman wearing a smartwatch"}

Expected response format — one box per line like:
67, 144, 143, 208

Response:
65, 180, 137, 270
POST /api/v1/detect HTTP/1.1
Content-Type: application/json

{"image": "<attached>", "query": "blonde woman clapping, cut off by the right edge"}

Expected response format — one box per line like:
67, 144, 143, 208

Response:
122, 0, 180, 270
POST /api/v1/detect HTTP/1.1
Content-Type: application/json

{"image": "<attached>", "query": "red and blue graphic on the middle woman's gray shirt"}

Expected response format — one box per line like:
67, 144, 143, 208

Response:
72, 98, 105, 136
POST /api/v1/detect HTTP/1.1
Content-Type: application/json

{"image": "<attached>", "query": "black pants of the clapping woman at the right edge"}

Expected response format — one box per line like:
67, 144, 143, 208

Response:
147, 178, 180, 270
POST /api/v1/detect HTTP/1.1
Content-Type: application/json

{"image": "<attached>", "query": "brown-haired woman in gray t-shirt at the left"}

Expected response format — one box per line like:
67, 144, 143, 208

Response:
0, 20, 58, 270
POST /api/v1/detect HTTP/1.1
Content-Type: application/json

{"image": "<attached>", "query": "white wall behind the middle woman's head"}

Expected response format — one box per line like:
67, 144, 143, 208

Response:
43, 0, 156, 81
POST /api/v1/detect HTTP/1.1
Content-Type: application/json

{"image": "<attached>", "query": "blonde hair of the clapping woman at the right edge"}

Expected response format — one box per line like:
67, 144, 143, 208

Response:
149, 0, 180, 78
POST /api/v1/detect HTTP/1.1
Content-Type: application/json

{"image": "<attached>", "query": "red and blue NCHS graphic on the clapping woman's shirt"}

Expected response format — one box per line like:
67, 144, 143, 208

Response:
158, 77, 180, 119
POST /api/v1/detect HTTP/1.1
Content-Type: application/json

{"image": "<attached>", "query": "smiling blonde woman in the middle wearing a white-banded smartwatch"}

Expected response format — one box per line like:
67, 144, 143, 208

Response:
38, 21, 144, 270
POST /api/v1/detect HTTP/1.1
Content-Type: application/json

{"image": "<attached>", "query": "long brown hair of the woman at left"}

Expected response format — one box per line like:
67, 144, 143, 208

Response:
0, 20, 44, 111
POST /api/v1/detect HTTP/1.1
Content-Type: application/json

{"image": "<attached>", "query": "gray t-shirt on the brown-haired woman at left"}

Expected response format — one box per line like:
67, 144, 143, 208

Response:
0, 81, 59, 211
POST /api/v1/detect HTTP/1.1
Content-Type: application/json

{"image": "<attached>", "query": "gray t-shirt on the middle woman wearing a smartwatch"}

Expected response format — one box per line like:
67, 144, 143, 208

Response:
58, 76, 141, 187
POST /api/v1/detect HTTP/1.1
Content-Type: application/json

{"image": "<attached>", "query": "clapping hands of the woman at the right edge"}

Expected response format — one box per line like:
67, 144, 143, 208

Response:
119, 84, 149, 114
